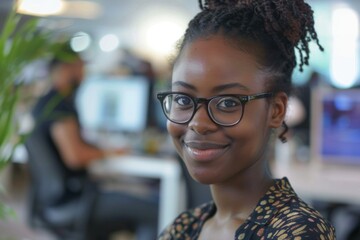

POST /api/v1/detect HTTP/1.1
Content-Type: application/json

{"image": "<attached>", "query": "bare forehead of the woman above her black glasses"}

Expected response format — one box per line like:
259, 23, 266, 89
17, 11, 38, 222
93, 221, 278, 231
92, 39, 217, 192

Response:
172, 36, 268, 91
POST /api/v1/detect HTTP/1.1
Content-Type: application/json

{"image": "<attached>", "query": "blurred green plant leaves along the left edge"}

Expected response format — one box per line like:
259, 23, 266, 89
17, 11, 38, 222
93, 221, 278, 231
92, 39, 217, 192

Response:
0, 10, 58, 219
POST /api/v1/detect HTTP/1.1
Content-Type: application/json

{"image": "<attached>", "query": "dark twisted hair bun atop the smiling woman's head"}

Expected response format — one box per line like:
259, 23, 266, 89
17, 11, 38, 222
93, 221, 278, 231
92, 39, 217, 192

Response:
199, 0, 323, 71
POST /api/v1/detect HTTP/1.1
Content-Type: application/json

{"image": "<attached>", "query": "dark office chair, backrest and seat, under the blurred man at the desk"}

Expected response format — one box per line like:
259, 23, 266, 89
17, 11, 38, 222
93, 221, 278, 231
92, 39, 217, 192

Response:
25, 129, 96, 240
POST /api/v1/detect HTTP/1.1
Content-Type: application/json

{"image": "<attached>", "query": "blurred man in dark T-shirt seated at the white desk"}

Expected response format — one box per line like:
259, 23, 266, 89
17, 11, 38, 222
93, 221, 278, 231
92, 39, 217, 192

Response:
30, 43, 158, 240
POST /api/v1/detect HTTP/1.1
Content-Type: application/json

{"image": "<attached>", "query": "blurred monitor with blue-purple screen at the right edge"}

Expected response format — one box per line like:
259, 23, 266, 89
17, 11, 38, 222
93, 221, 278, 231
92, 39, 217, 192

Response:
311, 89, 360, 166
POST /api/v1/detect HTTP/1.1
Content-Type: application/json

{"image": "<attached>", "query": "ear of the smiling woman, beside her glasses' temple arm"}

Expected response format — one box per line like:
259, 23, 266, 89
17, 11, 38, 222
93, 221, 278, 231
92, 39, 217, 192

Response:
269, 92, 288, 128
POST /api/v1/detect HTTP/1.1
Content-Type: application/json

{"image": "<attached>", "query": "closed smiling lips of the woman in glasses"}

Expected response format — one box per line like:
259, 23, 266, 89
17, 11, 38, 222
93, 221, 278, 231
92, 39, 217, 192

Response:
185, 143, 228, 162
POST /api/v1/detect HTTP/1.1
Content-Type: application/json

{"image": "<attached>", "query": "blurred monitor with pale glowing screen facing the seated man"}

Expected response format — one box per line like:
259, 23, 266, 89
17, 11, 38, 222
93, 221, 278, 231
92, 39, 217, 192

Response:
77, 76, 149, 133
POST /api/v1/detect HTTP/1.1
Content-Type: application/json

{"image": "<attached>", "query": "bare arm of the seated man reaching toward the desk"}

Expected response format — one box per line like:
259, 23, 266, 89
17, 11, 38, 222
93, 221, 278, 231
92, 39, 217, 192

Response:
51, 117, 126, 169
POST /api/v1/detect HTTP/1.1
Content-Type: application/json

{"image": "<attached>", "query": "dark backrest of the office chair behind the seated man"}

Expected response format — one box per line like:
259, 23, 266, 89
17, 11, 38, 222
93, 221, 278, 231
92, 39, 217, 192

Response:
25, 129, 66, 204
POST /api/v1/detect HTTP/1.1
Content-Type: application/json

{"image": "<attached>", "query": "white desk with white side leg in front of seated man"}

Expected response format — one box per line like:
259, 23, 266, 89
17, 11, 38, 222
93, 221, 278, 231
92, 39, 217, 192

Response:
90, 155, 183, 232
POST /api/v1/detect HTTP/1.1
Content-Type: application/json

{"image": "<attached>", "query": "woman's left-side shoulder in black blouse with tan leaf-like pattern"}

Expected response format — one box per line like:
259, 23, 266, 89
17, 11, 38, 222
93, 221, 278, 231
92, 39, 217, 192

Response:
158, 202, 215, 240
